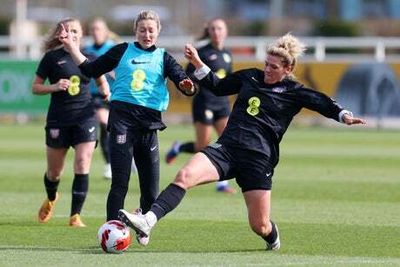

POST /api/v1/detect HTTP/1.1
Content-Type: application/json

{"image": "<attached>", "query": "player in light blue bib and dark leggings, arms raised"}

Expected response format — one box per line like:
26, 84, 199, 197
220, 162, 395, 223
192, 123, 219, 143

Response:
60, 11, 195, 244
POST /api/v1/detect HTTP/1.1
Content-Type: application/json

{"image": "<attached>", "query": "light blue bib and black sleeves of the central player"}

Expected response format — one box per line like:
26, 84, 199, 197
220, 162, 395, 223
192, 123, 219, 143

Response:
79, 42, 188, 112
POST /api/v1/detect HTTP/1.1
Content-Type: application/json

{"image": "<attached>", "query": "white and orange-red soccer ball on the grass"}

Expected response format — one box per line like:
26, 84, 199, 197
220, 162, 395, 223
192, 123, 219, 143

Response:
97, 220, 132, 253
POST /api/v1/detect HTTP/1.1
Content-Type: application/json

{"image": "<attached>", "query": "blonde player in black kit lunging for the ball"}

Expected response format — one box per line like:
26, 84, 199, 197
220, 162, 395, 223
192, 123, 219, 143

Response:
119, 34, 366, 250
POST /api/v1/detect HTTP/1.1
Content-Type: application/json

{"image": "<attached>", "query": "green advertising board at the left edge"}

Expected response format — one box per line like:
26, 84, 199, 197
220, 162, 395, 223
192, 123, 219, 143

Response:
0, 60, 50, 115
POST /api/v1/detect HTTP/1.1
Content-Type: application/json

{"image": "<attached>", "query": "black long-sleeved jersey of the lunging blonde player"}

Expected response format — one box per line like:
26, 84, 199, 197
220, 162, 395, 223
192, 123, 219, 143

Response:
200, 69, 343, 165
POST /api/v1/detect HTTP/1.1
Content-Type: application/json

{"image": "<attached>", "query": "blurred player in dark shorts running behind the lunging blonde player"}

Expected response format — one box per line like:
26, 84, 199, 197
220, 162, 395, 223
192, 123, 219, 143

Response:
165, 18, 236, 193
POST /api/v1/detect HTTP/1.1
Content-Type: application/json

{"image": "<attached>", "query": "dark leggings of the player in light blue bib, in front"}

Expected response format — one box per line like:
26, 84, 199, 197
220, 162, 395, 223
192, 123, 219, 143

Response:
107, 128, 160, 220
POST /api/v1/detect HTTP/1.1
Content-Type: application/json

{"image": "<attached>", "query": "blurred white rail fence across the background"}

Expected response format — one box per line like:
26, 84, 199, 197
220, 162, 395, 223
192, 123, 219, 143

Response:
0, 36, 400, 62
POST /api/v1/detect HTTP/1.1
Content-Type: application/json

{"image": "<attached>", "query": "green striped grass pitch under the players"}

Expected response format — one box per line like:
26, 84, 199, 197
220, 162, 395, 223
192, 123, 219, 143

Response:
0, 123, 400, 266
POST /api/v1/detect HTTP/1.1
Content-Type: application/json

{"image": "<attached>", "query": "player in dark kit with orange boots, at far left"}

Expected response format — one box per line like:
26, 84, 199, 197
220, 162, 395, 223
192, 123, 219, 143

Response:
32, 19, 110, 227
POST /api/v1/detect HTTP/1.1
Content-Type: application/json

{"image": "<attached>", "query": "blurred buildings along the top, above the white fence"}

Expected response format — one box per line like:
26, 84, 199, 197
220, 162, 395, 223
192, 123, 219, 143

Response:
0, 0, 400, 36
